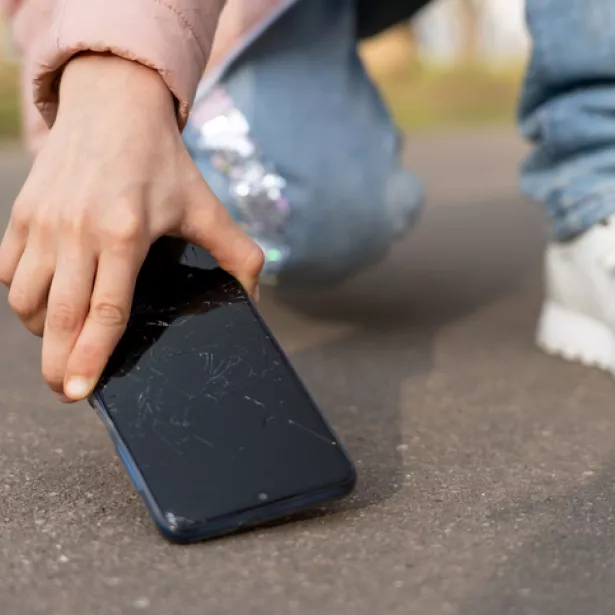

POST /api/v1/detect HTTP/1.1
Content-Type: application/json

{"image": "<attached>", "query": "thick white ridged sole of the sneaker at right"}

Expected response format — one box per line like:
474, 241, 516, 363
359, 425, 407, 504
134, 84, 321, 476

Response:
536, 302, 615, 375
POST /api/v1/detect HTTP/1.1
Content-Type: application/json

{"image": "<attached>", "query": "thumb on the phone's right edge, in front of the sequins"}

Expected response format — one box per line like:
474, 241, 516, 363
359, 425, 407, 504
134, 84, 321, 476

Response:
181, 177, 264, 296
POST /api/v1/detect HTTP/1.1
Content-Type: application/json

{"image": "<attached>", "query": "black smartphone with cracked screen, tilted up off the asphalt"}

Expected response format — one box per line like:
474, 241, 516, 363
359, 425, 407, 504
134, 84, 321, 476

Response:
90, 240, 356, 542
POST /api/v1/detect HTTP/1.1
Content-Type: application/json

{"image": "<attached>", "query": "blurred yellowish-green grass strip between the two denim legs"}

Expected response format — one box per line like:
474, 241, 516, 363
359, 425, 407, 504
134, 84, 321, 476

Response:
373, 65, 523, 130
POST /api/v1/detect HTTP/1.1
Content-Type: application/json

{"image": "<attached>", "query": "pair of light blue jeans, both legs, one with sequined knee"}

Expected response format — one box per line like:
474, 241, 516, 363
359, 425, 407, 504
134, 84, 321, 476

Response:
184, 0, 615, 284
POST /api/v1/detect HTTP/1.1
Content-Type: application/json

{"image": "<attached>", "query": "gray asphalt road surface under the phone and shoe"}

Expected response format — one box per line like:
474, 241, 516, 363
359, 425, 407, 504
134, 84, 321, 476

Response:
0, 134, 615, 615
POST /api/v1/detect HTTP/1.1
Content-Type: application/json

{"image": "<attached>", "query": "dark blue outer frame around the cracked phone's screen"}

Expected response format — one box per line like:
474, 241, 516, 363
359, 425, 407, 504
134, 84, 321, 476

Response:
88, 294, 357, 544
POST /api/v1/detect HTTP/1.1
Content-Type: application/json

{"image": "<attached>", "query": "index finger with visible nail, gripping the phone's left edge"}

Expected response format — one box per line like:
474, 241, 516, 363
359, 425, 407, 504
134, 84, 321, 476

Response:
64, 245, 146, 401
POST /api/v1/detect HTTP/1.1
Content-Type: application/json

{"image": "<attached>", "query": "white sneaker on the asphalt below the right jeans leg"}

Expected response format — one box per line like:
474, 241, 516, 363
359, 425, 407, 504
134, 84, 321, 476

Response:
537, 216, 615, 375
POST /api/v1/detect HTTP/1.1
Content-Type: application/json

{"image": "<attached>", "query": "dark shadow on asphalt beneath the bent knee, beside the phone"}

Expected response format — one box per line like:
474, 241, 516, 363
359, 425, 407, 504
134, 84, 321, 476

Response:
274, 192, 544, 507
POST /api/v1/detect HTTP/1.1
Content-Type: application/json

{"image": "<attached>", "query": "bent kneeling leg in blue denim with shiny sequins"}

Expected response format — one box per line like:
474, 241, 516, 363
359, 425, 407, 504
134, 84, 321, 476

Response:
184, 0, 422, 284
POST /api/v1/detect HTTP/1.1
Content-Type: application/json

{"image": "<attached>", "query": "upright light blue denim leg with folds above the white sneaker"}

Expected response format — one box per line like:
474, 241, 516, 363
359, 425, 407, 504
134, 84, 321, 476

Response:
519, 0, 615, 240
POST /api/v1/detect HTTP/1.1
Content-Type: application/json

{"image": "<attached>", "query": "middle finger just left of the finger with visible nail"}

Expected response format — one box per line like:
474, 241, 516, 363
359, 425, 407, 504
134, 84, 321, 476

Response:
42, 243, 96, 395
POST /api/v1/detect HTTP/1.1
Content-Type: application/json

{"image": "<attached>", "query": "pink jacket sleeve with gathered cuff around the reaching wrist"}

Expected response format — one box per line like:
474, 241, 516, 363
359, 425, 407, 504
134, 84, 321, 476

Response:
0, 0, 225, 126
